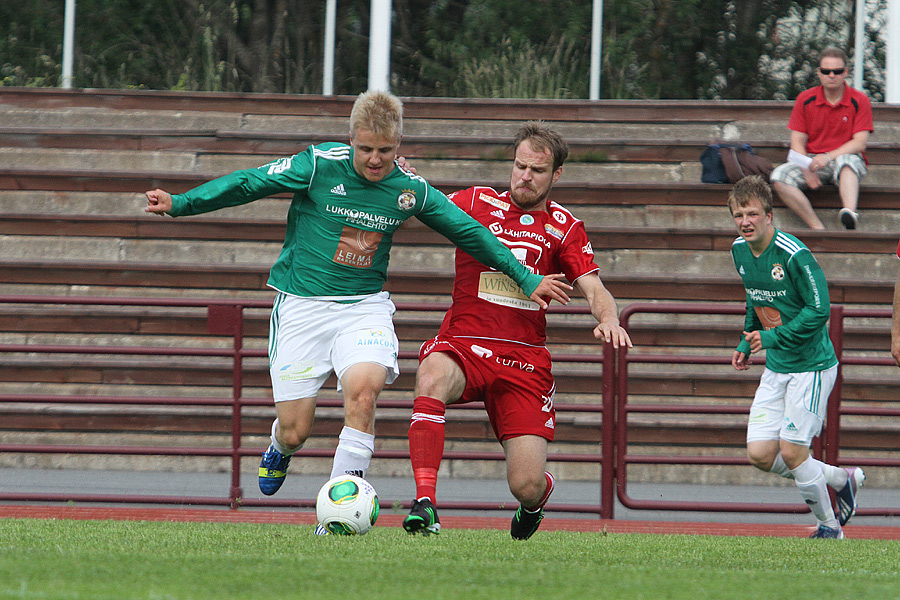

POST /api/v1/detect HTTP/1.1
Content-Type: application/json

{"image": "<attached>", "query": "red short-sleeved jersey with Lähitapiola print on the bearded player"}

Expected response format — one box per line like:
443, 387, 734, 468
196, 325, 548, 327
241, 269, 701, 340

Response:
440, 187, 599, 346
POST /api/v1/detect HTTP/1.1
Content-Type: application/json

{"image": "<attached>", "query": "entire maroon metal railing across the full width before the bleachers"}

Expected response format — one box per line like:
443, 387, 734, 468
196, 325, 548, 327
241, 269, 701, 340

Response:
0, 296, 900, 519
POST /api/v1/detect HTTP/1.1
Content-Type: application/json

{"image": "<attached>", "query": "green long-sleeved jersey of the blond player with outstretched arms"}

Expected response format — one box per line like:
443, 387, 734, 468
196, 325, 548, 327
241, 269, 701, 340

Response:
170, 143, 541, 300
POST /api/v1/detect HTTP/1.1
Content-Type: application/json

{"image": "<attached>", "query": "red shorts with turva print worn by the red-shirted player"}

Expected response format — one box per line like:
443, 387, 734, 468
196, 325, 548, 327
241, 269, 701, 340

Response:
419, 335, 556, 442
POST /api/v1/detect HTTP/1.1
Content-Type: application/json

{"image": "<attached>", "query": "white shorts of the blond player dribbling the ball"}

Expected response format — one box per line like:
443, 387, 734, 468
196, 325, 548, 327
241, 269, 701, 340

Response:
269, 292, 400, 402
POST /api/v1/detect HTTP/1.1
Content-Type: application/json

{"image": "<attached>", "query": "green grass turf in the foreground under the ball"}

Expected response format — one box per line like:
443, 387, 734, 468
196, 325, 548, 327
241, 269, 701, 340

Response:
0, 519, 900, 600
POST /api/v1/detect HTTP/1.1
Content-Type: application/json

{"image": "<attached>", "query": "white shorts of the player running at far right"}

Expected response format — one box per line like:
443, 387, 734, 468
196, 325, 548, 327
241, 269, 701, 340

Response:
747, 365, 837, 447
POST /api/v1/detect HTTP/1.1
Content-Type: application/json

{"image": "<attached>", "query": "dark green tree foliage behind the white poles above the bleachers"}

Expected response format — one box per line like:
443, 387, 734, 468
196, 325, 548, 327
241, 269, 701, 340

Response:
0, 0, 886, 99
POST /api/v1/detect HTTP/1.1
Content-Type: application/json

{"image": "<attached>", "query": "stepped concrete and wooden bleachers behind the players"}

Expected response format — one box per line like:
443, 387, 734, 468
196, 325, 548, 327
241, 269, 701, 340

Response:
0, 88, 900, 486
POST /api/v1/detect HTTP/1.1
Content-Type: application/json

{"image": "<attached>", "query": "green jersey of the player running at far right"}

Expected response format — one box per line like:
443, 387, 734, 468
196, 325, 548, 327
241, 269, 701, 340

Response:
731, 229, 837, 373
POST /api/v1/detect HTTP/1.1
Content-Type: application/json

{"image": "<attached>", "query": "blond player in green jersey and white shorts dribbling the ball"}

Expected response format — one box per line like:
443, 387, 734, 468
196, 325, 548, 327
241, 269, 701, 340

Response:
145, 91, 571, 533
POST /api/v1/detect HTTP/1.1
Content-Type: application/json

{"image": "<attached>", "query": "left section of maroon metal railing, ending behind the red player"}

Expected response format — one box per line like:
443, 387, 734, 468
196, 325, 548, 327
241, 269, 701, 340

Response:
0, 296, 615, 514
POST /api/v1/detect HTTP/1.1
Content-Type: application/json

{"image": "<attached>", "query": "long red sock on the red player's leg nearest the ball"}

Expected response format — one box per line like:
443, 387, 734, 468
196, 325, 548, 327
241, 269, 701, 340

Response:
409, 396, 446, 503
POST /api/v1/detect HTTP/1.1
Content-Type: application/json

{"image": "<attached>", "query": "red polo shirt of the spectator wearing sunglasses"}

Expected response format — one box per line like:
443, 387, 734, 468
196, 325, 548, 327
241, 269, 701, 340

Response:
788, 85, 872, 156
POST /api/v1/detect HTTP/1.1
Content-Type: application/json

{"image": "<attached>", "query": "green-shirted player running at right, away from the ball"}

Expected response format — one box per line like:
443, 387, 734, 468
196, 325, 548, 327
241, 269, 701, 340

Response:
728, 176, 865, 539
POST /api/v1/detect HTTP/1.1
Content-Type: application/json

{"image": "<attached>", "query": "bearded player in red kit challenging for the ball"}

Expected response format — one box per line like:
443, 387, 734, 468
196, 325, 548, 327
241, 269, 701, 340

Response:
403, 121, 631, 539
